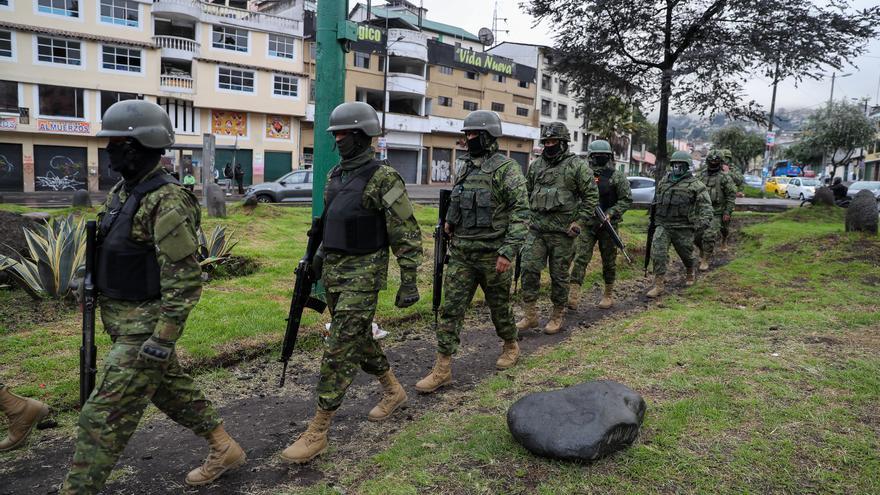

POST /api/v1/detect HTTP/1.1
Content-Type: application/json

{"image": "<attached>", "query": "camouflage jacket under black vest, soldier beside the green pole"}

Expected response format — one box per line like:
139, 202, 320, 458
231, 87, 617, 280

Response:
322, 157, 422, 292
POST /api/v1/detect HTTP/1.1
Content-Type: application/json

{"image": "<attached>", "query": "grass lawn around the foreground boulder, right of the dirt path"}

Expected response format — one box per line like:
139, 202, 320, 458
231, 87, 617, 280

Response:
296, 208, 880, 494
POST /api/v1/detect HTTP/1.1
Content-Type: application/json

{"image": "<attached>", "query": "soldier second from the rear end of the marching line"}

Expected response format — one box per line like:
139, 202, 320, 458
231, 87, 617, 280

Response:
696, 150, 736, 272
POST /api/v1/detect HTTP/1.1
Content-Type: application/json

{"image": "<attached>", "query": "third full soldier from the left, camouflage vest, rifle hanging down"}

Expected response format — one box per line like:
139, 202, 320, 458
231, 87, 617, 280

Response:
416, 110, 529, 393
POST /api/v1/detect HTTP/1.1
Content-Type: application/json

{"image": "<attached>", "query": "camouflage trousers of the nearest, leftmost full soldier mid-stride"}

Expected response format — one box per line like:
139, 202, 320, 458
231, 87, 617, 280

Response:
61, 335, 221, 494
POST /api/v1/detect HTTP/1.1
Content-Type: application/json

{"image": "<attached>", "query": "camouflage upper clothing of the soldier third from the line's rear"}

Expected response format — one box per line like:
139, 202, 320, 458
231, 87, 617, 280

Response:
651, 173, 712, 228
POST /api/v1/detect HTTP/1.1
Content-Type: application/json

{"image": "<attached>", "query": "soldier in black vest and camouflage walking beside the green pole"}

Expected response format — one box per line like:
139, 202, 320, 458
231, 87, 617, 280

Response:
281, 102, 422, 464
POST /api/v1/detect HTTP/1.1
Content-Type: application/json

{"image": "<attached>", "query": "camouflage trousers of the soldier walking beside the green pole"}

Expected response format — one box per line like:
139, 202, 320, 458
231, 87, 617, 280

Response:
318, 290, 390, 411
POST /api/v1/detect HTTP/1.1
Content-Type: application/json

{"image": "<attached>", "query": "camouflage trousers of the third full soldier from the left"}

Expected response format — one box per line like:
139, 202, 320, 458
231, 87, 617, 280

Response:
437, 246, 517, 356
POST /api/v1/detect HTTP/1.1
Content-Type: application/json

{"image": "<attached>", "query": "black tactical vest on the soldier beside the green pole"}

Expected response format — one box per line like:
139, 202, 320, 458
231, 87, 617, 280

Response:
323, 160, 388, 255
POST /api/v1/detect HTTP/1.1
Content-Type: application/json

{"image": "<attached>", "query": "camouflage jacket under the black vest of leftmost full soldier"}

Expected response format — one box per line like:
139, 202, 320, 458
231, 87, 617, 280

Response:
98, 165, 202, 341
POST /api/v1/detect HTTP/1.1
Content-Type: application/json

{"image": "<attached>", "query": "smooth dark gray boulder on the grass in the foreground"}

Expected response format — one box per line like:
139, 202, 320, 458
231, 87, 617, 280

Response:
507, 380, 646, 461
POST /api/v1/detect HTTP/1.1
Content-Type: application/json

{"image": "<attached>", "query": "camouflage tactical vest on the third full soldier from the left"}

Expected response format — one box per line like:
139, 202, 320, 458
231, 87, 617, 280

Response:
446, 153, 510, 240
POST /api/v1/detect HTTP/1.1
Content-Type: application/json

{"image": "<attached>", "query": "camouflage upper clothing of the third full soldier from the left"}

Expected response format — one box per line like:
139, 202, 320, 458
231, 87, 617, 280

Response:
446, 144, 529, 260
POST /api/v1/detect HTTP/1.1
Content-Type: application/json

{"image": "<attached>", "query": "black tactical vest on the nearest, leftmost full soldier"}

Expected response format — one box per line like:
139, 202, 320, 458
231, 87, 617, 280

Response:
96, 172, 180, 301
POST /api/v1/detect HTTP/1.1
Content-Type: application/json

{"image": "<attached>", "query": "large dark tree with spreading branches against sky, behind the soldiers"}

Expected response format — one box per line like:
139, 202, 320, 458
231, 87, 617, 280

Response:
523, 0, 880, 175
